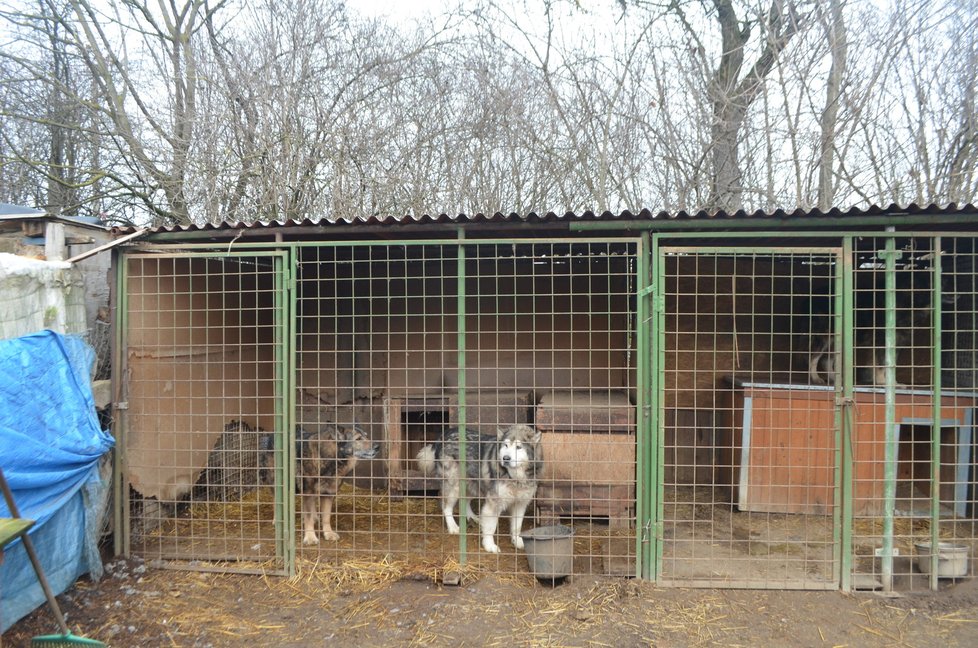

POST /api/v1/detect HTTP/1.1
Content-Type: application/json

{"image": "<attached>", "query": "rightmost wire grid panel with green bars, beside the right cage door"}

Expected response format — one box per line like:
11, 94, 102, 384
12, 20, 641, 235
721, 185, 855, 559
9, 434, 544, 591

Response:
852, 237, 978, 591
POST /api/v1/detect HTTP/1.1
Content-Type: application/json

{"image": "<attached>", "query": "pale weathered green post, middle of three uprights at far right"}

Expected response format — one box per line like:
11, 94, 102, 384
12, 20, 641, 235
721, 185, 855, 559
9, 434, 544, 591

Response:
881, 236, 899, 592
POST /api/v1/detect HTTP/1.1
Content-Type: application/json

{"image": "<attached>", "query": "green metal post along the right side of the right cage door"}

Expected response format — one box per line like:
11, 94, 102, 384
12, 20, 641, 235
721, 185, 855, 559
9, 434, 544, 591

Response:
836, 236, 856, 592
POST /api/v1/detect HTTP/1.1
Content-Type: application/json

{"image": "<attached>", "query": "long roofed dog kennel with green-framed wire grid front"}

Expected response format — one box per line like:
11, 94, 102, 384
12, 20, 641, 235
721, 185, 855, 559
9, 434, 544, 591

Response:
113, 206, 978, 590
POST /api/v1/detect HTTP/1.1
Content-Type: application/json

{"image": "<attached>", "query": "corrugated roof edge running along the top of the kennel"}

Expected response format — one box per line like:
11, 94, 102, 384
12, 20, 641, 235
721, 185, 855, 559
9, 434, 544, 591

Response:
113, 203, 978, 234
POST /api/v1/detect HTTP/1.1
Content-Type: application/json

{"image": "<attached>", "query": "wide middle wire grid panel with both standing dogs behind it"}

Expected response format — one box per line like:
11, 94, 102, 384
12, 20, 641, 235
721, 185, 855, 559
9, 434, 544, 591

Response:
296, 240, 636, 575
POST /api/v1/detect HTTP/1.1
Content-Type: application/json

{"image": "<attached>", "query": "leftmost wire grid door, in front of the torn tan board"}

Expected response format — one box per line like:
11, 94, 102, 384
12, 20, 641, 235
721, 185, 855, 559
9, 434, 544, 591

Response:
120, 253, 286, 571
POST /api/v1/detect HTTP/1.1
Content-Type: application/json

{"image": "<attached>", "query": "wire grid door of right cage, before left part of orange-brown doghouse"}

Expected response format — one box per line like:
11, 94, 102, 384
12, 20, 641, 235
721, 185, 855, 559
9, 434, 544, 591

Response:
657, 247, 841, 589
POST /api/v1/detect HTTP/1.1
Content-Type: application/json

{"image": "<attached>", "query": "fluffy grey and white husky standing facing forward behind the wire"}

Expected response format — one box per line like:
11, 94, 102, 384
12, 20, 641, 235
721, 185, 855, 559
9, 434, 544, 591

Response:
417, 424, 543, 553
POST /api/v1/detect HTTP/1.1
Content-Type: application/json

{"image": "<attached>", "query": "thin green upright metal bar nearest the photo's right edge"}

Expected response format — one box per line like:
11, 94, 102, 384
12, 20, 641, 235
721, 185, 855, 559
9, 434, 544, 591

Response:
930, 236, 940, 591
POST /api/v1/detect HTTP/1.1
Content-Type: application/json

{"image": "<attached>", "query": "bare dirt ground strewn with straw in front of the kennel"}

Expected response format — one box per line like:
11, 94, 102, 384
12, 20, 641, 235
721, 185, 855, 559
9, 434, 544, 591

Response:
0, 559, 978, 648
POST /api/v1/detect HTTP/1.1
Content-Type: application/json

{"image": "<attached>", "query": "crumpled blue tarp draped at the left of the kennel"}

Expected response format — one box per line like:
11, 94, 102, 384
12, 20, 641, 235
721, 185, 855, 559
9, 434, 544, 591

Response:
0, 331, 114, 632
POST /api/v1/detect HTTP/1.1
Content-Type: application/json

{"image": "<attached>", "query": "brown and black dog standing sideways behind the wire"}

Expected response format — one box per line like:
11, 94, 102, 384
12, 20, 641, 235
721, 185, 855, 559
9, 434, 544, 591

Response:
296, 424, 380, 545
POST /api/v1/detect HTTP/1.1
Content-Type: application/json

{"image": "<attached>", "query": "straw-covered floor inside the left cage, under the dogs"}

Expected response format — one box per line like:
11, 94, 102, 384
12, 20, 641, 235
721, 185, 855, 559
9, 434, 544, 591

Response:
131, 485, 635, 576
